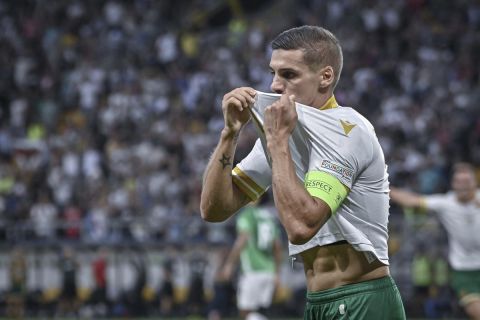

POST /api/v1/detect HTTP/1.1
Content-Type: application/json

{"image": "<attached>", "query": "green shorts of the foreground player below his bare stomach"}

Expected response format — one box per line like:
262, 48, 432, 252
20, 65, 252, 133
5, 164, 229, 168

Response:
303, 276, 406, 320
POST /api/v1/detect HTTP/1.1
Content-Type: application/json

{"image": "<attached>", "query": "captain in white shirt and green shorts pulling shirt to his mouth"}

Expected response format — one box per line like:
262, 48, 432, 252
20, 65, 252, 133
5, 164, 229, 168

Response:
201, 26, 405, 319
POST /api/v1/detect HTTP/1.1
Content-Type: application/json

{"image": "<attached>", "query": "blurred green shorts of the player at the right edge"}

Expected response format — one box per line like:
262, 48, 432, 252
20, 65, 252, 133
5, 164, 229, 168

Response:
451, 270, 480, 305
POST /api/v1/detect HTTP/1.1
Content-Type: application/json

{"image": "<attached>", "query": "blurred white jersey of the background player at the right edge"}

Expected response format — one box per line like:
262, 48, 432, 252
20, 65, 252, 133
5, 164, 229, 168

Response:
423, 190, 480, 271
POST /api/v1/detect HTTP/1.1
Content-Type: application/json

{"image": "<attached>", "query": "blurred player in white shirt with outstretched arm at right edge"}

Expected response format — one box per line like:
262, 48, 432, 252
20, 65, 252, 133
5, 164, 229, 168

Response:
390, 163, 480, 319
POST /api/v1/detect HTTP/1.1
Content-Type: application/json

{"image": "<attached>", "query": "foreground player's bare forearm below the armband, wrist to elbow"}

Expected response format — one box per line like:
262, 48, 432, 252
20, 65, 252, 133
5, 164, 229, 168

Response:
270, 142, 330, 244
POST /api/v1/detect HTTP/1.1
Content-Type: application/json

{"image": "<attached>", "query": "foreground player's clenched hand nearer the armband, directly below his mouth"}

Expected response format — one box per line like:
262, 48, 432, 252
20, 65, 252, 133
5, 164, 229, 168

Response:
263, 94, 298, 144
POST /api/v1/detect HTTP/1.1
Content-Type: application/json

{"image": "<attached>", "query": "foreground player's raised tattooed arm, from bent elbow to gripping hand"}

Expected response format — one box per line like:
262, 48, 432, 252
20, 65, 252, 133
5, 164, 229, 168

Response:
200, 88, 256, 222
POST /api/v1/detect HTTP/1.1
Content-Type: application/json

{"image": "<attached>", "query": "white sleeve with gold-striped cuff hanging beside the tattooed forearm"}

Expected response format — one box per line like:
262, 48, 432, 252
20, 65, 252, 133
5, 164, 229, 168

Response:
232, 139, 272, 201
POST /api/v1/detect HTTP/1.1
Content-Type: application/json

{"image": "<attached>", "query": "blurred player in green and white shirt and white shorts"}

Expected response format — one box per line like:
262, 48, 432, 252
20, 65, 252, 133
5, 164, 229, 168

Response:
220, 197, 282, 320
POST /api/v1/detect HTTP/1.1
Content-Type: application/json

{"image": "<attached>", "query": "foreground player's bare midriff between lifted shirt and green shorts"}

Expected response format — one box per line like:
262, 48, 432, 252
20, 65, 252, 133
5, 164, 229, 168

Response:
301, 241, 389, 292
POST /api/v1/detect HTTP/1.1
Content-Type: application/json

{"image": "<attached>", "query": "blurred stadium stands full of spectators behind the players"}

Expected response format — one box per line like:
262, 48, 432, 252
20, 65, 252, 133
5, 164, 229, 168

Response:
0, 0, 480, 319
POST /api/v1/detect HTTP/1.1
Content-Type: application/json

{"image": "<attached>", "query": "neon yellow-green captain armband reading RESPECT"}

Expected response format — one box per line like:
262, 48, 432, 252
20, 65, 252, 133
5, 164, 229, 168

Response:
305, 171, 348, 214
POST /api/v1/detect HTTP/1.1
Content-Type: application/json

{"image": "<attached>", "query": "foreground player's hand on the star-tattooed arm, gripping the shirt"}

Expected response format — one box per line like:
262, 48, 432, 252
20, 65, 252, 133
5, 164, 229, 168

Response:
222, 87, 257, 133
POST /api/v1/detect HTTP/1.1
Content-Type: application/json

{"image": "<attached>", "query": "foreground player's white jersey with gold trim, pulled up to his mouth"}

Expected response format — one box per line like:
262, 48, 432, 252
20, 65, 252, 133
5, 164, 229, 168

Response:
232, 92, 389, 264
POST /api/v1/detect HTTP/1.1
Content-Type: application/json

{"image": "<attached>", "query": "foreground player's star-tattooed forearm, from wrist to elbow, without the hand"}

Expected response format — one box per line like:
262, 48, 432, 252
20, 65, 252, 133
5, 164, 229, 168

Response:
200, 130, 239, 222
